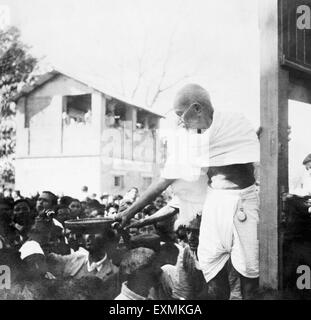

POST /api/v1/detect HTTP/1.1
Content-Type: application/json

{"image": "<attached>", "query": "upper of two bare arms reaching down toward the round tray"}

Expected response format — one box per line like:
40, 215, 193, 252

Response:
116, 178, 175, 228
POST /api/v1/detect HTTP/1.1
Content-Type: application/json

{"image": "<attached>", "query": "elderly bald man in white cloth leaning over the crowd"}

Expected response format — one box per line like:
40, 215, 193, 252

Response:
119, 84, 259, 299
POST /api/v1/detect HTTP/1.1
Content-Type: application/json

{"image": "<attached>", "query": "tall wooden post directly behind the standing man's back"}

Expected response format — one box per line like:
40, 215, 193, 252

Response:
259, 0, 289, 289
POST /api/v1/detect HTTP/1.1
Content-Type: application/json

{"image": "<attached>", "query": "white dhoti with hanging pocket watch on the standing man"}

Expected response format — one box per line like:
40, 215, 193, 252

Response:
198, 186, 259, 282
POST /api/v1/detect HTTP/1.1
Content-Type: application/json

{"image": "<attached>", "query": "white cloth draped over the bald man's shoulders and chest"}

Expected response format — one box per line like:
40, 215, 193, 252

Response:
162, 111, 260, 181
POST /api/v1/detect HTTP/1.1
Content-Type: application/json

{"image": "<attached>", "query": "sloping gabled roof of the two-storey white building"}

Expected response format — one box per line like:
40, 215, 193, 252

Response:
13, 69, 164, 118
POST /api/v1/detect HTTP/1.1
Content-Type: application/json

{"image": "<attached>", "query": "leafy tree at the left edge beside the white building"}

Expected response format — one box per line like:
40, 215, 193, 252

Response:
0, 27, 38, 183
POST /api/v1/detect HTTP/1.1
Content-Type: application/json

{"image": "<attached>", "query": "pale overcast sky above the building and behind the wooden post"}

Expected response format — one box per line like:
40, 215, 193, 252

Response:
0, 0, 311, 186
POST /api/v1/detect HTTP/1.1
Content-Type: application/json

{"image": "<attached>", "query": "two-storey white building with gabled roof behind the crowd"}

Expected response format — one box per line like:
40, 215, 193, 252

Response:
15, 71, 166, 196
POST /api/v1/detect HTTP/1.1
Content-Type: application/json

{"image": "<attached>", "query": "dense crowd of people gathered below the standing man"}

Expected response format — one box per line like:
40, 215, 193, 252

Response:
0, 187, 212, 300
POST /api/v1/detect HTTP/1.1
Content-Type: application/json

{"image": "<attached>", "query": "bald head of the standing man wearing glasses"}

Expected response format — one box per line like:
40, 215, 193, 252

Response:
174, 84, 214, 129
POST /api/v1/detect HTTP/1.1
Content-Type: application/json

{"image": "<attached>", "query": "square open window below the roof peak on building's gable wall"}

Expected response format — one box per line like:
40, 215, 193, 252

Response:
63, 94, 92, 125
